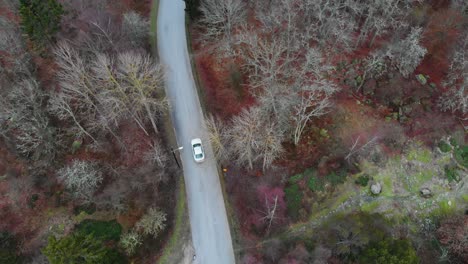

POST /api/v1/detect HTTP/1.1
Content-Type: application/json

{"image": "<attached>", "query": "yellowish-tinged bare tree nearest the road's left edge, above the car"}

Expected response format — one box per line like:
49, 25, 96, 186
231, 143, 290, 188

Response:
92, 52, 168, 134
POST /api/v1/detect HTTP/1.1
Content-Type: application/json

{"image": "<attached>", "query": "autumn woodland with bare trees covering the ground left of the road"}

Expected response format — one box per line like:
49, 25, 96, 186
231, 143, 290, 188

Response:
0, 0, 177, 264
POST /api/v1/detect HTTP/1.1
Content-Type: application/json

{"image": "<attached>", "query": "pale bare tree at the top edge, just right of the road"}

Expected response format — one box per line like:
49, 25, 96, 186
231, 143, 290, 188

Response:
199, 0, 246, 52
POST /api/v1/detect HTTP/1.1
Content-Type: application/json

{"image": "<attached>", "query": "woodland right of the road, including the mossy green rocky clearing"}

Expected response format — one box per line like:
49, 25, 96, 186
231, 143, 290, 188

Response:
186, 0, 468, 264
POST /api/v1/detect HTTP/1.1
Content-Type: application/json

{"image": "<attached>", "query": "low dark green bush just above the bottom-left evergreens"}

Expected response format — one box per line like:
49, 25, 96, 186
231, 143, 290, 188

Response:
76, 219, 122, 241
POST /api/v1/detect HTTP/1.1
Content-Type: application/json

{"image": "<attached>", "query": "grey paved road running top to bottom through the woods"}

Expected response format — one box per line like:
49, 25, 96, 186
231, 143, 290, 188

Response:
158, 0, 234, 264
